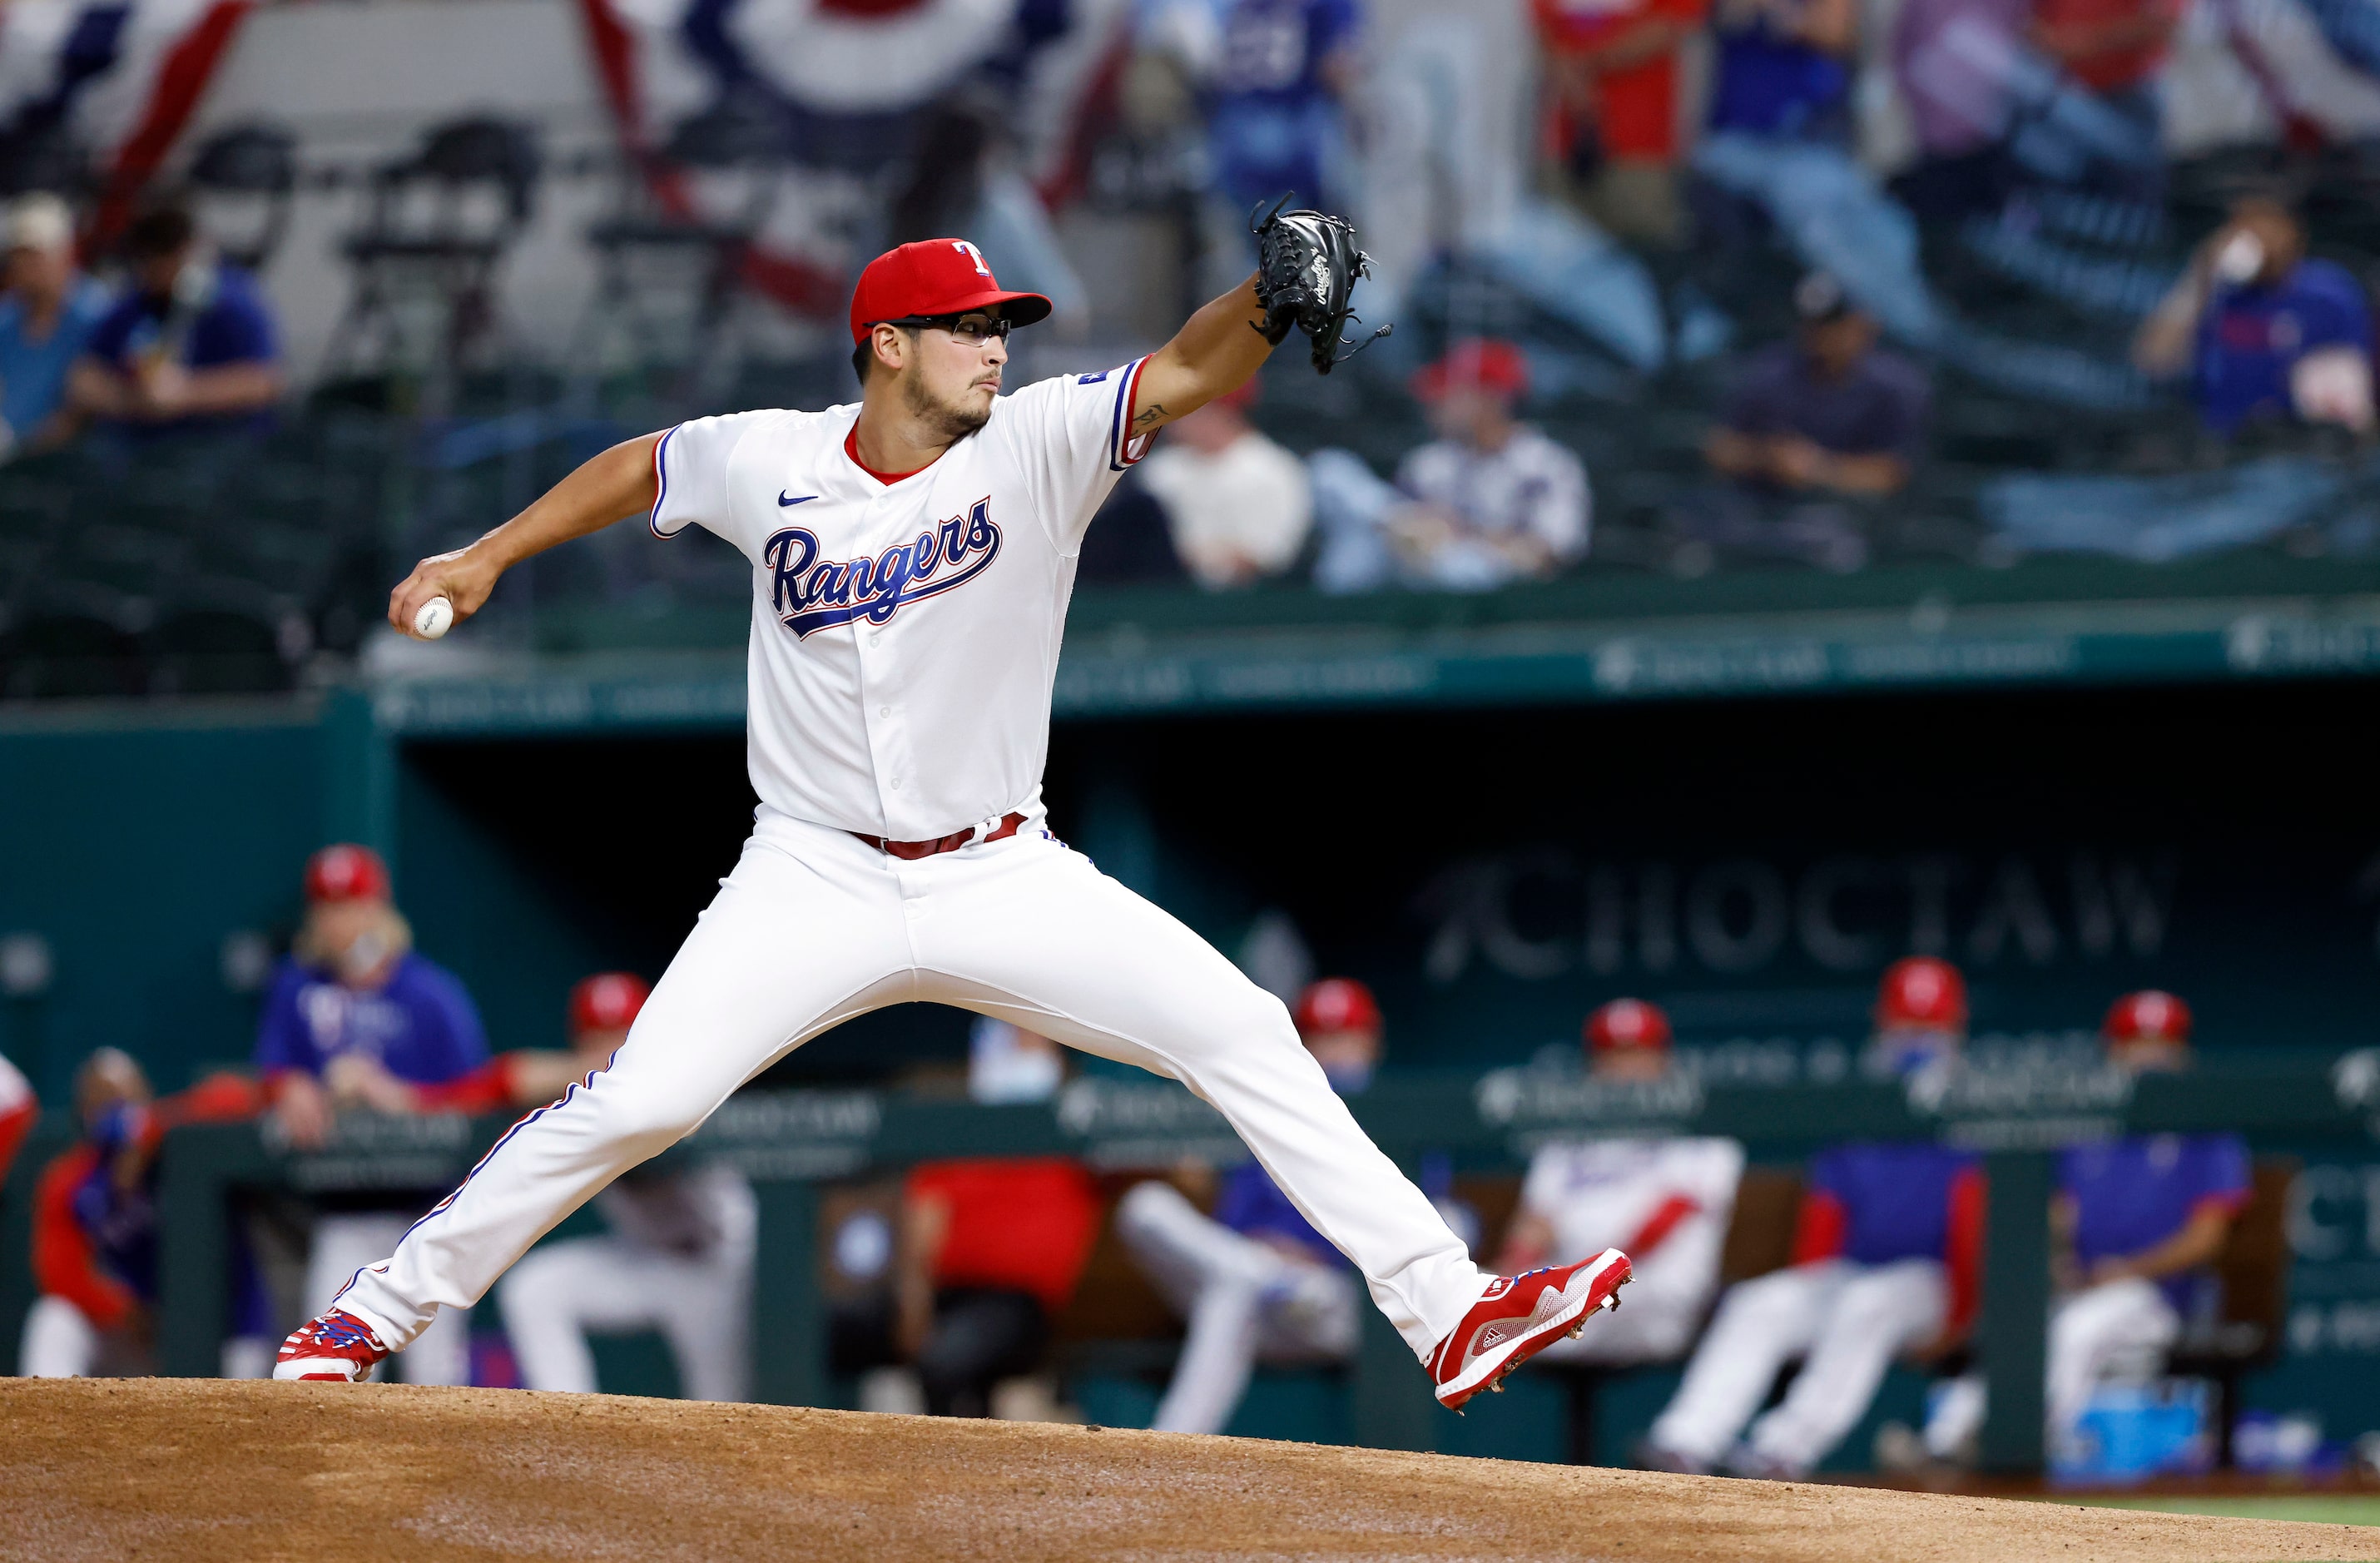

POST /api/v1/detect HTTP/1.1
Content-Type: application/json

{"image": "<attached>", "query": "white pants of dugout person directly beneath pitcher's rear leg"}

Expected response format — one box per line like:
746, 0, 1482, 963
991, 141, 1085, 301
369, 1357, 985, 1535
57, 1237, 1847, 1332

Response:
495, 1237, 752, 1402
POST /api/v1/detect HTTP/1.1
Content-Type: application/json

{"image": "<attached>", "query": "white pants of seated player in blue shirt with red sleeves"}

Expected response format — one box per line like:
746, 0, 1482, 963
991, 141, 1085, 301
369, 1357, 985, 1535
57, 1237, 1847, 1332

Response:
1621, 1258, 1949, 1472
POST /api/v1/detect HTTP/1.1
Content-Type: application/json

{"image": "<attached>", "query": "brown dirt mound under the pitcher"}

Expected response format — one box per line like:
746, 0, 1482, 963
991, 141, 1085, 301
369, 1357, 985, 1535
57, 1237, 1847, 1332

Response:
0, 1380, 2380, 1563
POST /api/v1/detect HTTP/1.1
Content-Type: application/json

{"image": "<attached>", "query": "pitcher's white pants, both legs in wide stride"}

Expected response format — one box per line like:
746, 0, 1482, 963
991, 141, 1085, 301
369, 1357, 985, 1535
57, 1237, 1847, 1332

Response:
338, 809, 1488, 1358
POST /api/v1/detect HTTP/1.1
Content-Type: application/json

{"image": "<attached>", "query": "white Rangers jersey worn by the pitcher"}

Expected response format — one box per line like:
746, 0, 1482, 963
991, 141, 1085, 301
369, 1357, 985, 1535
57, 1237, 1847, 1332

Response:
652, 360, 1148, 842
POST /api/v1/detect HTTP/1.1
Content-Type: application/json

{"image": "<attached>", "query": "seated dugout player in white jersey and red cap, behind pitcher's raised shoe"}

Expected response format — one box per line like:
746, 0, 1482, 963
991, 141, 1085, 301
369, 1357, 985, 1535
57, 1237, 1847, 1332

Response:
1495, 1000, 1744, 1363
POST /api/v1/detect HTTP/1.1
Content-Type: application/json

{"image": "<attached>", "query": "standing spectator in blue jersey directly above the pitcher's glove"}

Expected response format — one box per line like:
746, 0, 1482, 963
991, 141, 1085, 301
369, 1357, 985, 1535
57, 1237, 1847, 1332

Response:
1207, 0, 1364, 217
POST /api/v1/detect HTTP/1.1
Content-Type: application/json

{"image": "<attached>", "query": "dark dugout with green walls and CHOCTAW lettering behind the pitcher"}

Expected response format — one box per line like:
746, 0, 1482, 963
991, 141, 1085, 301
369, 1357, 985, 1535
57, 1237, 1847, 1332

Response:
0, 642, 2380, 1454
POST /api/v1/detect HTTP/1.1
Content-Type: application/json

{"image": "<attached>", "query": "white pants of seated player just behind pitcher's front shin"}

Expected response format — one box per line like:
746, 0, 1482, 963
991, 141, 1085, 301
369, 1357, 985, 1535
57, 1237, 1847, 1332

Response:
1116, 1183, 1361, 1432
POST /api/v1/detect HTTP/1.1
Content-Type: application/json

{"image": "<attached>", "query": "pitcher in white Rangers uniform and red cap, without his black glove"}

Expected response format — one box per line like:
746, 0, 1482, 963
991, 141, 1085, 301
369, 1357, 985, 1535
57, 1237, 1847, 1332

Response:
276, 241, 1628, 1406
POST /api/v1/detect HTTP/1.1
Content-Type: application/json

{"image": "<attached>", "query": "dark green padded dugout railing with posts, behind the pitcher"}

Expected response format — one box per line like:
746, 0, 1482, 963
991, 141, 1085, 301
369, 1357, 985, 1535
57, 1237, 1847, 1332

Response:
0, 1049, 2380, 1475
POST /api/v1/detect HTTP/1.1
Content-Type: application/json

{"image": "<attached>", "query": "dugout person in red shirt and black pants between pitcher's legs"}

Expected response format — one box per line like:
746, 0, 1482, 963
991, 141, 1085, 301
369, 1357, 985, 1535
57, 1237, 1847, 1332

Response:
893, 1025, 1099, 1416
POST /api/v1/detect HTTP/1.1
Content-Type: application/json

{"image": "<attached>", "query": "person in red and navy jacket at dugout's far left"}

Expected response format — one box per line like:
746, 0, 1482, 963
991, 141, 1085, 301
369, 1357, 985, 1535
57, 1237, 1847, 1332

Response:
19, 1047, 274, 1377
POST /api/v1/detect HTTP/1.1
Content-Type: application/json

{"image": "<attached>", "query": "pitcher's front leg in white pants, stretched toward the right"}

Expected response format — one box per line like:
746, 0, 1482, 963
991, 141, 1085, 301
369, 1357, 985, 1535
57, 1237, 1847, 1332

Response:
905, 837, 1490, 1358
